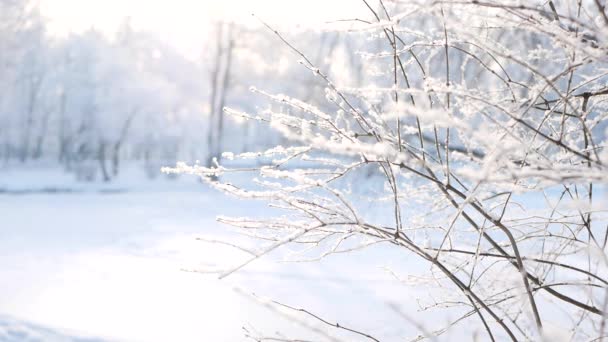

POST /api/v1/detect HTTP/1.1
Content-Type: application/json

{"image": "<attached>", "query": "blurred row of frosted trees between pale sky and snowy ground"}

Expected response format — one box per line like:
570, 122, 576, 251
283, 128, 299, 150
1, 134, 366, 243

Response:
0, 0, 366, 180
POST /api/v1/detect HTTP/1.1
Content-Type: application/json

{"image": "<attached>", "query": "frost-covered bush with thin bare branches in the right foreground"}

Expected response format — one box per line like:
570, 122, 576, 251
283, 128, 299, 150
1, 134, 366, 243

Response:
166, 0, 608, 341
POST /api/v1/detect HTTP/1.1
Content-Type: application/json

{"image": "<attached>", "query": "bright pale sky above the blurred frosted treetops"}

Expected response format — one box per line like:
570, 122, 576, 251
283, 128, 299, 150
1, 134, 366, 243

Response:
40, 0, 364, 57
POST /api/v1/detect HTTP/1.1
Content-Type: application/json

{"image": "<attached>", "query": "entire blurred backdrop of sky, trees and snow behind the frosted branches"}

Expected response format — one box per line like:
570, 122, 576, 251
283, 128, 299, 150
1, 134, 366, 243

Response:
0, 0, 426, 341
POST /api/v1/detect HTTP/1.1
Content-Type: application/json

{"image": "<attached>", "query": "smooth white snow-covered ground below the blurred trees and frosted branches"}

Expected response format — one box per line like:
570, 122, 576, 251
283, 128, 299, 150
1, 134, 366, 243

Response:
0, 164, 456, 341
